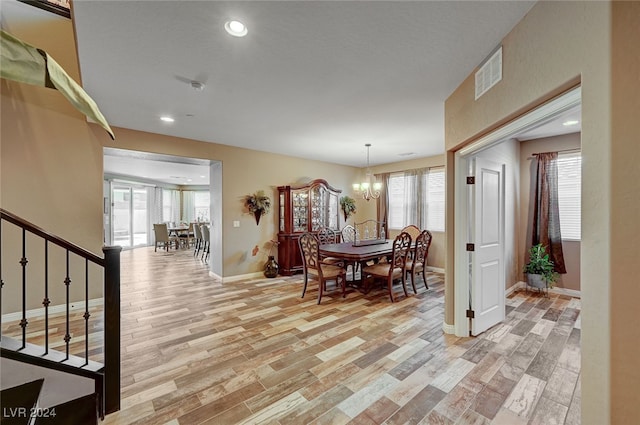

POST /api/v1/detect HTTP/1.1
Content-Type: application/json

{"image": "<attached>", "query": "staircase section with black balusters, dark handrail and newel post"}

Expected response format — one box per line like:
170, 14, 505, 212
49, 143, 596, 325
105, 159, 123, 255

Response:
0, 209, 121, 425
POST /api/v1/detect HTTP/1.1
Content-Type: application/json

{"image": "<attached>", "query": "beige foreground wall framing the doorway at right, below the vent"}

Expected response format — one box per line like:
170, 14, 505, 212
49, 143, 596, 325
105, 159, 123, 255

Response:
445, 2, 640, 424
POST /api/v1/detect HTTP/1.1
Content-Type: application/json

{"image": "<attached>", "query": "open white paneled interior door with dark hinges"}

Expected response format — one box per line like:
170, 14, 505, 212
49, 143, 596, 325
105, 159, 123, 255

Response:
470, 158, 505, 335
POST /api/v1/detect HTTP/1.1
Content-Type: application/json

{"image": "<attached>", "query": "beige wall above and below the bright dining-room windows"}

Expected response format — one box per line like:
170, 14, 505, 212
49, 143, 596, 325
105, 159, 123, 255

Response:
368, 155, 446, 269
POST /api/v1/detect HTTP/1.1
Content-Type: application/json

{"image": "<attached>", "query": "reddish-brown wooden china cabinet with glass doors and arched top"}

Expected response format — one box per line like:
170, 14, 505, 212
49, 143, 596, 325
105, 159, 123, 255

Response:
278, 179, 342, 276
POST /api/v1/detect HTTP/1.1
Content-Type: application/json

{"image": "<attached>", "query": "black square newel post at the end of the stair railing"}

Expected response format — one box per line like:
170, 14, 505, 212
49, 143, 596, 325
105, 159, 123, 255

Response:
102, 246, 122, 413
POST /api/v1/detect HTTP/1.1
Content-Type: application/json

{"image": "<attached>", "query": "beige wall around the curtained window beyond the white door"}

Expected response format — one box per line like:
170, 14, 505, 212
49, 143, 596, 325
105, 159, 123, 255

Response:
518, 133, 580, 291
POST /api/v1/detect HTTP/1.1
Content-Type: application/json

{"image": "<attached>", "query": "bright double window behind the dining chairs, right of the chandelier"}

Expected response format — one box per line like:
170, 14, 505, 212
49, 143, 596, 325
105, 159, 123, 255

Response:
387, 169, 445, 232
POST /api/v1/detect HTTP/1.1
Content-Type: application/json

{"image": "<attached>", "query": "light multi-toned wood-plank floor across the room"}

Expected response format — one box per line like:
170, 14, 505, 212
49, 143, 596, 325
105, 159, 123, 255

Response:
1, 248, 580, 425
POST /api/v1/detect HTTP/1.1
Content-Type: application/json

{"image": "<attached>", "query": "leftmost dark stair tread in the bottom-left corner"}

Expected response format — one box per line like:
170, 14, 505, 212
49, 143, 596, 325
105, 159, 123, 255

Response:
0, 379, 44, 425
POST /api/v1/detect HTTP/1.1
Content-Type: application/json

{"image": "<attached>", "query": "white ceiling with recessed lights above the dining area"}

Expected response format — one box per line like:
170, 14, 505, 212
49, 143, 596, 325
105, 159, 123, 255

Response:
66, 0, 534, 167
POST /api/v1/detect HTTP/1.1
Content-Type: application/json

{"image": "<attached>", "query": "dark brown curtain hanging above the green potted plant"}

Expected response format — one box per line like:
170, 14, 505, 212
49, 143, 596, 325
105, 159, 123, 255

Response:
531, 152, 567, 273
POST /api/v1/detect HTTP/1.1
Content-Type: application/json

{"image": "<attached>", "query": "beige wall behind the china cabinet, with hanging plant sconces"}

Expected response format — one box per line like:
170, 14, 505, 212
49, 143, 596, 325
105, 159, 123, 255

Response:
100, 128, 360, 277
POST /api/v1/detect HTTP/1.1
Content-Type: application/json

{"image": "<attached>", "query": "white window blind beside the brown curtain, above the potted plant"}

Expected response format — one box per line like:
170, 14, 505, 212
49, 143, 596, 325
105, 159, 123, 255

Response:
558, 153, 582, 240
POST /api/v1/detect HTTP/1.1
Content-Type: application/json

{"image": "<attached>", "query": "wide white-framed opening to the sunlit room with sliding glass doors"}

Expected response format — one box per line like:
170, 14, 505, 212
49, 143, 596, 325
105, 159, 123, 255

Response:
103, 148, 222, 276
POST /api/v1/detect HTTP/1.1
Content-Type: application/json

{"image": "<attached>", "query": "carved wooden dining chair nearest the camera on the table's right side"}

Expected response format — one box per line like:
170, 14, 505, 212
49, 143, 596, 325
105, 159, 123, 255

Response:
362, 232, 411, 302
